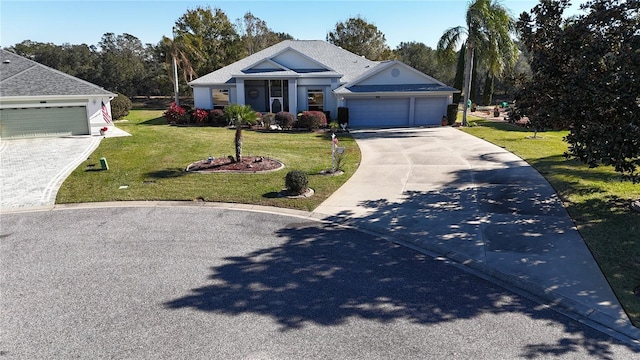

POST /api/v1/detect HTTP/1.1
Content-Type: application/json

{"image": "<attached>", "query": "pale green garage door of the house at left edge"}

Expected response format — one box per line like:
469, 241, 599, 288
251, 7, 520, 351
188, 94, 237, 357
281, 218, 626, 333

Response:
0, 106, 90, 139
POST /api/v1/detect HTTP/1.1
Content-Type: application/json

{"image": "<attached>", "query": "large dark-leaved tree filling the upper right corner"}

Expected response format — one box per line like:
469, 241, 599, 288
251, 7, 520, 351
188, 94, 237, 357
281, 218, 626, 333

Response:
516, 0, 640, 180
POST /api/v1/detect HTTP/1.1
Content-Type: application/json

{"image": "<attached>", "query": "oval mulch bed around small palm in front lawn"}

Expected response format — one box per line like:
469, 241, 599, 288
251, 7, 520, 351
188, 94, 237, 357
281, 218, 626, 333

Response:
186, 156, 284, 173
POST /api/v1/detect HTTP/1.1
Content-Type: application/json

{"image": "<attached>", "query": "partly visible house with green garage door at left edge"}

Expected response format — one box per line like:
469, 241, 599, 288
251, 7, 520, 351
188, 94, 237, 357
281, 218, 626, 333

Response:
0, 49, 116, 139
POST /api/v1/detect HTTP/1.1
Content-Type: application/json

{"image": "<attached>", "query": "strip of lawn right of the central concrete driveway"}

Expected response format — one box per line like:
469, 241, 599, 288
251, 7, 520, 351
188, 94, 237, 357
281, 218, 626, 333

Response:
463, 118, 640, 326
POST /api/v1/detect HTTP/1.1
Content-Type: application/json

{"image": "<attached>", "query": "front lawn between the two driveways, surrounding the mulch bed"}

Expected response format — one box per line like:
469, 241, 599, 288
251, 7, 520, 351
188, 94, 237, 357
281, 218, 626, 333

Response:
56, 110, 360, 210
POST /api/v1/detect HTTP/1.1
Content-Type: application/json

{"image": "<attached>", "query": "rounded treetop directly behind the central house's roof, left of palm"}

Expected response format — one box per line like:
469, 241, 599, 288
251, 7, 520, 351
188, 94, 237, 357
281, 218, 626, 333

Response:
327, 16, 394, 60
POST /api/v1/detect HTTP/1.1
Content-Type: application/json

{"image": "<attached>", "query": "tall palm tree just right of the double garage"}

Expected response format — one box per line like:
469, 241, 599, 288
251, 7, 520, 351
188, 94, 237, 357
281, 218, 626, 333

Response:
437, 0, 518, 126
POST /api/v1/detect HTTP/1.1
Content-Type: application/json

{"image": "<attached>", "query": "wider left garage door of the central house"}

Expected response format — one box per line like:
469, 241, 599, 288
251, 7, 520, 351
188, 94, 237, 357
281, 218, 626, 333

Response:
347, 98, 409, 127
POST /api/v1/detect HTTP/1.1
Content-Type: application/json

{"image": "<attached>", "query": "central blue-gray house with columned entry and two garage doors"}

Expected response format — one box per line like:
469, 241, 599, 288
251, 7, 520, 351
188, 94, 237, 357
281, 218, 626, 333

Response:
189, 40, 459, 127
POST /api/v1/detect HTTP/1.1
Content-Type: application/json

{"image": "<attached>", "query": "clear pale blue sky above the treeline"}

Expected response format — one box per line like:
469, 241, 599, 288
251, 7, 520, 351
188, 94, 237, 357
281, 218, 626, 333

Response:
0, 0, 582, 49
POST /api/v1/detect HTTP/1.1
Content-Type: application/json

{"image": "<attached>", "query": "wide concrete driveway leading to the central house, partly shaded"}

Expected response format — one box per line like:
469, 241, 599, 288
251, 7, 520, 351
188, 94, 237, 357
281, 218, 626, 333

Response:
314, 127, 640, 344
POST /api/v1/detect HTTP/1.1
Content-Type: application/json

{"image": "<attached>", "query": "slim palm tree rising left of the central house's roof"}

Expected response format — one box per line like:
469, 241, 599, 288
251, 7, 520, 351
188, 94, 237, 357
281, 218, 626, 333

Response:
162, 33, 203, 105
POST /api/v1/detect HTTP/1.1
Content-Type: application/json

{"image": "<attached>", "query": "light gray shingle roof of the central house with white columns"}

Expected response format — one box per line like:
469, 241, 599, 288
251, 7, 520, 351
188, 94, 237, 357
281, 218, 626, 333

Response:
189, 40, 378, 86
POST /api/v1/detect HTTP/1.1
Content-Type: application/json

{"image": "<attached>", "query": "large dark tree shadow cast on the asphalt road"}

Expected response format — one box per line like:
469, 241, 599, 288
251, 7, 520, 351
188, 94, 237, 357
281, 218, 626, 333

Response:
165, 222, 632, 359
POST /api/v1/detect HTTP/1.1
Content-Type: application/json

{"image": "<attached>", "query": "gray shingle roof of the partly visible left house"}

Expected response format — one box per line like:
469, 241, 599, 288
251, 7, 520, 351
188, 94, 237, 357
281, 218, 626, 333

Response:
0, 49, 115, 97
